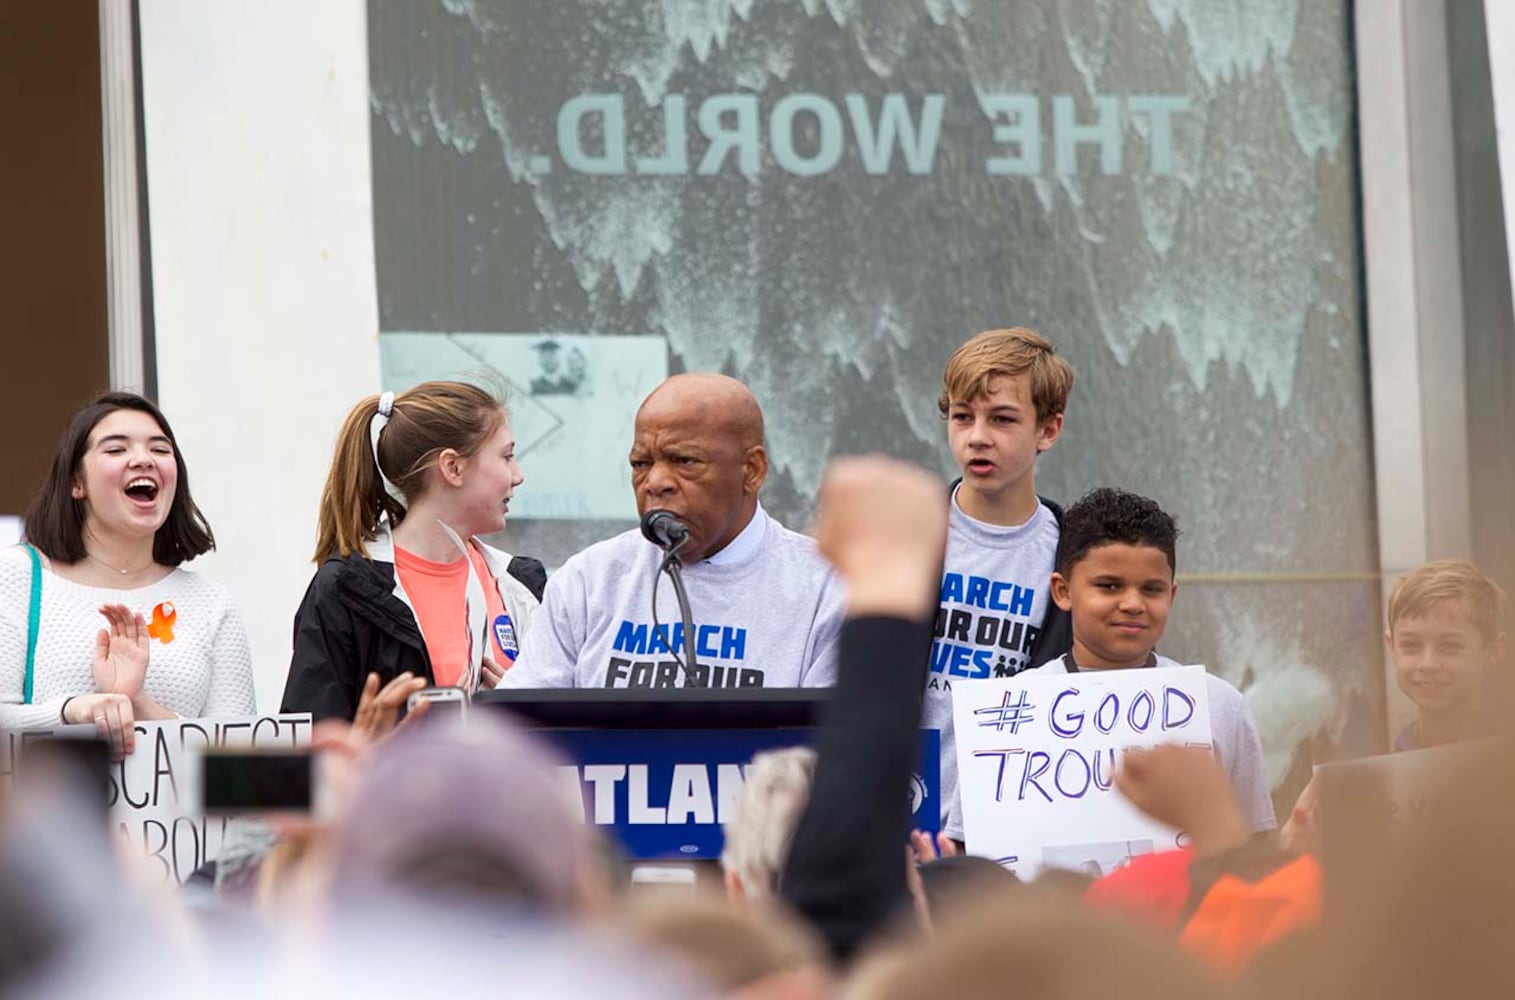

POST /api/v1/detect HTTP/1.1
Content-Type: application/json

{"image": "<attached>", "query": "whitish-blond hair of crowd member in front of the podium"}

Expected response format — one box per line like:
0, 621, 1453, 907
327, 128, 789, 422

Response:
721, 747, 815, 900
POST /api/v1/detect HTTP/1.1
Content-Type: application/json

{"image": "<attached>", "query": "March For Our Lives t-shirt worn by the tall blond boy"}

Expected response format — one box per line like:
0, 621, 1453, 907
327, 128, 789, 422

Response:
921, 486, 1057, 839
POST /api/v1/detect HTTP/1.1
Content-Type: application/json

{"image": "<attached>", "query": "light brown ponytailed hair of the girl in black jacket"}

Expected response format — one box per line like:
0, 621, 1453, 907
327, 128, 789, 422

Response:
315, 382, 504, 562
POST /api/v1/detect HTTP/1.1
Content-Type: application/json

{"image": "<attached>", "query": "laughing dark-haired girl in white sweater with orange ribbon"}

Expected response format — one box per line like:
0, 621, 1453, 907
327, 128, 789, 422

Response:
0, 392, 255, 755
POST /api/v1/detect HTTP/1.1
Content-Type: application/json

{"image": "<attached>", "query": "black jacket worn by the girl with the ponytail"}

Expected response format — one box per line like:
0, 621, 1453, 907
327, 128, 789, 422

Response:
279, 555, 547, 720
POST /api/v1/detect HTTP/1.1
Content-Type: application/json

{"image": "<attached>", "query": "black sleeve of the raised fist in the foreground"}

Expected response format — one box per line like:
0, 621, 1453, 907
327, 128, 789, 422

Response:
779, 618, 932, 961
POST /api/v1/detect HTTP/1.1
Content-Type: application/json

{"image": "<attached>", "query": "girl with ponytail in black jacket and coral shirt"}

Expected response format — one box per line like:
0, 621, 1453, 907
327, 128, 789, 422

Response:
283, 382, 547, 720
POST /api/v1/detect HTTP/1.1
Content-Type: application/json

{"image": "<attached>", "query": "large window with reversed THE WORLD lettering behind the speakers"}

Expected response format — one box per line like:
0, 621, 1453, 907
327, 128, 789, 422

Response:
370, 0, 1382, 788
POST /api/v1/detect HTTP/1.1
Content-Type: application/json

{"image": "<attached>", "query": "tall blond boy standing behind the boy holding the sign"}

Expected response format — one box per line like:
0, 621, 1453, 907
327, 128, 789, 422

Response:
921, 327, 1073, 841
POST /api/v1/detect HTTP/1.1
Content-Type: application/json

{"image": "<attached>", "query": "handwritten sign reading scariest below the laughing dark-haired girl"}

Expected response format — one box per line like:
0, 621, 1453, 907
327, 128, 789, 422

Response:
0, 714, 311, 885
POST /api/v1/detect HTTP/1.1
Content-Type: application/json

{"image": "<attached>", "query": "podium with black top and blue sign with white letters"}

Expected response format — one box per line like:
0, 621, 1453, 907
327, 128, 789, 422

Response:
474, 688, 941, 861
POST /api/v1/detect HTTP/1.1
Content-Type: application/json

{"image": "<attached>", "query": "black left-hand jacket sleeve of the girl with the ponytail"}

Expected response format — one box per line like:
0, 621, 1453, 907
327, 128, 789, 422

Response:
279, 564, 358, 721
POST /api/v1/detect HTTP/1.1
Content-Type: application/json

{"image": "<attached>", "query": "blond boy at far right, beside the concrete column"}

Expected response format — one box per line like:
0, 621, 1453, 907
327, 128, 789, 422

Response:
1385, 559, 1504, 750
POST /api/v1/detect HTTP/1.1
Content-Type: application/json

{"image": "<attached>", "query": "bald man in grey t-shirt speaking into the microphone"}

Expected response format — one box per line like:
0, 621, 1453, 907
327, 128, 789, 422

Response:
501, 374, 845, 689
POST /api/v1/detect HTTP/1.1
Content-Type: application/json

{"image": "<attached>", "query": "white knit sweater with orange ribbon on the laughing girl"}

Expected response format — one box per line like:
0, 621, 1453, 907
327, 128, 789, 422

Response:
0, 547, 256, 729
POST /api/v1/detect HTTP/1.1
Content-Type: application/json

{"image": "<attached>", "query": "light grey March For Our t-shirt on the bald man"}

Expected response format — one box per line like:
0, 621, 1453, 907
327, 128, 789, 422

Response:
501, 508, 845, 689
